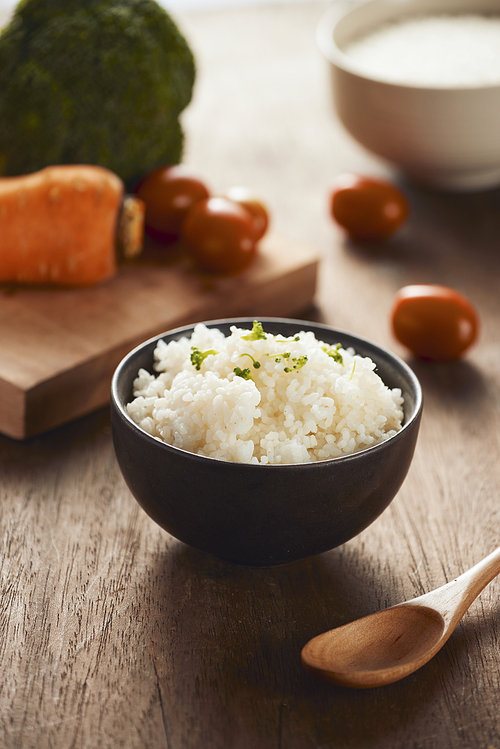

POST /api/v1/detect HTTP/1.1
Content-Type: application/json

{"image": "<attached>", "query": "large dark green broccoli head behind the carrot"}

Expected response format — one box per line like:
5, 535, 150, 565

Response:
0, 0, 195, 182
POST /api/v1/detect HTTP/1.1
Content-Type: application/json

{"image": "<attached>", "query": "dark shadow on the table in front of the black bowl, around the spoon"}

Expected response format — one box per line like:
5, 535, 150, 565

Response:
144, 544, 460, 749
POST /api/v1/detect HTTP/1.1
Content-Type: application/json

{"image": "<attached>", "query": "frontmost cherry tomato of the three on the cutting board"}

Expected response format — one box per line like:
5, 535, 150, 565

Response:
182, 197, 256, 275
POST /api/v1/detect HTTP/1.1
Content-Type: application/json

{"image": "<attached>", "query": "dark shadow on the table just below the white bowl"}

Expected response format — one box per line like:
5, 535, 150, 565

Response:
336, 181, 500, 300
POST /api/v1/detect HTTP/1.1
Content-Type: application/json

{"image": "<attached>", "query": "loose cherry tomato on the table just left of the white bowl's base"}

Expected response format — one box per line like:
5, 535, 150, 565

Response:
330, 174, 408, 242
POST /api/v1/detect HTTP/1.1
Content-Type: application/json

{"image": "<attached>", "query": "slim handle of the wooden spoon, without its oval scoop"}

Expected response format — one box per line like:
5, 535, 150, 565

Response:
415, 547, 500, 630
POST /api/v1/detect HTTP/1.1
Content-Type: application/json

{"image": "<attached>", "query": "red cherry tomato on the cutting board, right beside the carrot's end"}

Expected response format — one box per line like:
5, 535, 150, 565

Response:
136, 165, 209, 240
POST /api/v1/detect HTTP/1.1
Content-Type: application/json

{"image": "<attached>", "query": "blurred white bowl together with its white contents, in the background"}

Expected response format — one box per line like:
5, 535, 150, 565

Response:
317, 0, 500, 191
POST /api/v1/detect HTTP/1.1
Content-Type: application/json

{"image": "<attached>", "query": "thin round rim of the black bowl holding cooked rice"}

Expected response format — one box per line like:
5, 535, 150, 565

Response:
111, 316, 423, 470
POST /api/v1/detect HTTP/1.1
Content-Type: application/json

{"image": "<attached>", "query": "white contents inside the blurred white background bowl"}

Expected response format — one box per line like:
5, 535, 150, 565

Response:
343, 14, 500, 88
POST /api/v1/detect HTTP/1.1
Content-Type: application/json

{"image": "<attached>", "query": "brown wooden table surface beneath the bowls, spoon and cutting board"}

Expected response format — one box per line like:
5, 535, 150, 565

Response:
0, 2, 500, 749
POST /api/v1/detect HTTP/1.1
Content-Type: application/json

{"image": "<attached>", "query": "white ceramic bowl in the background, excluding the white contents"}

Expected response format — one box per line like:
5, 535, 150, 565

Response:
317, 0, 500, 191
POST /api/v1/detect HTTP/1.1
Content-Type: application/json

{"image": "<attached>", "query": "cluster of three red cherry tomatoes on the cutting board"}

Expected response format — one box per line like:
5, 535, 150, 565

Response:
136, 165, 269, 275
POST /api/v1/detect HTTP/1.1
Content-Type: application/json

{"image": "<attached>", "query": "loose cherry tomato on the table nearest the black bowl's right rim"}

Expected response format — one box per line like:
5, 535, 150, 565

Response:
392, 284, 479, 362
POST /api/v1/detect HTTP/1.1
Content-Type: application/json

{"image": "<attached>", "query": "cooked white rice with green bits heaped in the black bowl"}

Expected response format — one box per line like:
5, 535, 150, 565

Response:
127, 324, 403, 463
